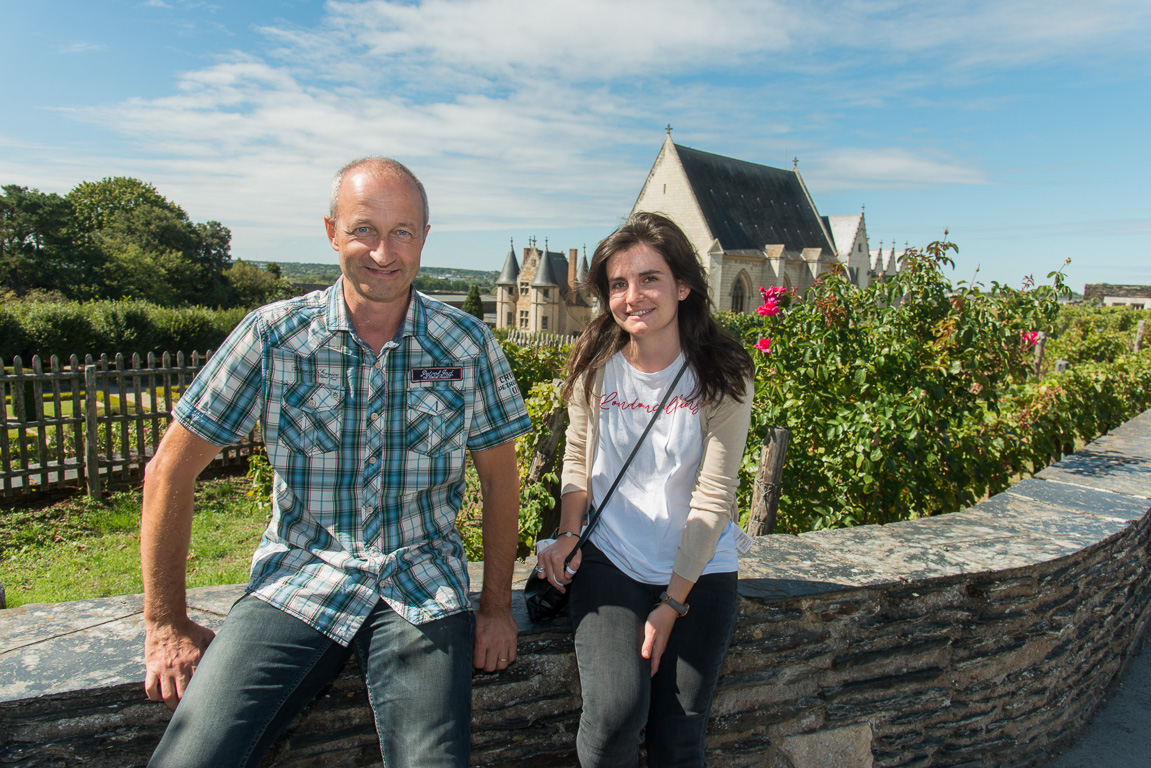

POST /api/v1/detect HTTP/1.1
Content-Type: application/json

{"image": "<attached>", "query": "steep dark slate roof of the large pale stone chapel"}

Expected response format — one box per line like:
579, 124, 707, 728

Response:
676, 144, 836, 253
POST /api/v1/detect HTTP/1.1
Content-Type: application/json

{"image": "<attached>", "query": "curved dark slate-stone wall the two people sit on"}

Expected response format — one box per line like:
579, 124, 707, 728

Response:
0, 411, 1151, 768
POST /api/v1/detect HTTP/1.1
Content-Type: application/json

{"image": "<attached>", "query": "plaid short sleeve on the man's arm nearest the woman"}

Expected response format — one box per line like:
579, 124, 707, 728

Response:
467, 333, 532, 450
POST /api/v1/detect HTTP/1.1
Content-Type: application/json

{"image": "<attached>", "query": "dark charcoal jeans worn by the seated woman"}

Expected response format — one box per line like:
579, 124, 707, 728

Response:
571, 543, 738, 768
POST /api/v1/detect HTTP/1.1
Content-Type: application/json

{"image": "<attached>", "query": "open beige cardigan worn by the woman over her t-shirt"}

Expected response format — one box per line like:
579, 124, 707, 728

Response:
561, 368, 755, 584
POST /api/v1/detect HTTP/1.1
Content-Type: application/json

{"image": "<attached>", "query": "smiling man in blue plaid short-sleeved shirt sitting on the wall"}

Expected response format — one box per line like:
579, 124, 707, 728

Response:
140, 158, 531, 768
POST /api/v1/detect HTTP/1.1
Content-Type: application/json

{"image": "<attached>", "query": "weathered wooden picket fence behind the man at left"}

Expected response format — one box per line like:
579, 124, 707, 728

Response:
0, 352, 264, 497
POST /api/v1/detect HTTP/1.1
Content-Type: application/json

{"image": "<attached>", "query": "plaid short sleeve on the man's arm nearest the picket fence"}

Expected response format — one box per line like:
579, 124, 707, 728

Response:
173, 312, 264, 446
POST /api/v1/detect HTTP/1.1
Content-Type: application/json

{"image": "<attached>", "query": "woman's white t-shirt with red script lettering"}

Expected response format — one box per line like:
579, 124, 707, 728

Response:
590, 352, 739, 584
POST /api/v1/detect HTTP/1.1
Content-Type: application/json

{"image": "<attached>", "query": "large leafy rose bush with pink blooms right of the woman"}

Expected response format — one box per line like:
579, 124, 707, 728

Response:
741, 243, 1062, 531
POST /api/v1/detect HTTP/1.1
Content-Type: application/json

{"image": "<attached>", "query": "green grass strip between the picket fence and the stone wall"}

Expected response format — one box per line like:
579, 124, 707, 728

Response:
0, 476, 268, 608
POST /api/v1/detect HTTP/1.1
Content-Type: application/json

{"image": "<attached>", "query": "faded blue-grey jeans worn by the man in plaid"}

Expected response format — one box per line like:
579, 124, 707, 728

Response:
148, 595, 475, 768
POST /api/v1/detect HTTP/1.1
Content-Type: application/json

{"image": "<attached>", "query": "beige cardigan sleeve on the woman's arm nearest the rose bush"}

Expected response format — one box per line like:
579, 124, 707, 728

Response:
672, 380, 755, 584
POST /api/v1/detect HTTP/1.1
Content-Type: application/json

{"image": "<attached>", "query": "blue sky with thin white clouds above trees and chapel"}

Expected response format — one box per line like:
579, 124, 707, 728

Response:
0, 0, 1151, 290
